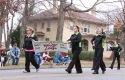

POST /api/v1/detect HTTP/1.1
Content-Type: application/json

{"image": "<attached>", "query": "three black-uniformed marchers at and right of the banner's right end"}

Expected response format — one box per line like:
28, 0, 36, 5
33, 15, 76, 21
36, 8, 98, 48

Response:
65, 26, 122, 74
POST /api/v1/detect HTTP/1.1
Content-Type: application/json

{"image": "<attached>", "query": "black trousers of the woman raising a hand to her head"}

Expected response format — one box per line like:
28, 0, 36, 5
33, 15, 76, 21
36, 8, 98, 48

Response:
94, 48, 106, 72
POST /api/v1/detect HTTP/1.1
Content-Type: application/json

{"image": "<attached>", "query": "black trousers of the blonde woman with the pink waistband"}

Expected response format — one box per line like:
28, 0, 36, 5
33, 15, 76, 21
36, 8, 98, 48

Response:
25, 52, 39, 72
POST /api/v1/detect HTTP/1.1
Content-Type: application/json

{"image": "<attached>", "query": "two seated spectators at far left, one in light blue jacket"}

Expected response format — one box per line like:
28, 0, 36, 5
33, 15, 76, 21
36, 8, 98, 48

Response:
0, 43, 20, 66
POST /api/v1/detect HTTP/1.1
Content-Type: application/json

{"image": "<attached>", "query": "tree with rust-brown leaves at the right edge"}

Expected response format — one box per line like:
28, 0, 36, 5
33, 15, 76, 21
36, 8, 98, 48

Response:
98, 0, 125, 58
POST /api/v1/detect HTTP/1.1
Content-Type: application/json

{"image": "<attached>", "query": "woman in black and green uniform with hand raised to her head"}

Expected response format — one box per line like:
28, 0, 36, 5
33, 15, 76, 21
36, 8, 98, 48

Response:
91, 28, 106, 74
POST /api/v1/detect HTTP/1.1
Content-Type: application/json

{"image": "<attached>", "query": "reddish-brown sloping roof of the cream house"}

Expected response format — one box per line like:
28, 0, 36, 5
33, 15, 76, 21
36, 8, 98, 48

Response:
29, 6, 106, 24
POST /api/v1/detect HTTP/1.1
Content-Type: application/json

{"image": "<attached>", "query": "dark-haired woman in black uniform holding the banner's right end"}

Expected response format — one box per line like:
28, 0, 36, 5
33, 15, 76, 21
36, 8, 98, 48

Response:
65, 26, 82, 74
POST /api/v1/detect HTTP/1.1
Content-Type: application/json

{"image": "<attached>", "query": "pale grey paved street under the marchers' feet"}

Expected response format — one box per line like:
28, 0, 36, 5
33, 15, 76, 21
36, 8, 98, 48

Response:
0, 68, 125, 80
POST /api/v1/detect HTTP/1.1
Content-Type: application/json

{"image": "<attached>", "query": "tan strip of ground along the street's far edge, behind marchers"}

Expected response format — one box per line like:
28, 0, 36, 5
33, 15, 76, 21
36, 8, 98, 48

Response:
0, 60, 125, 70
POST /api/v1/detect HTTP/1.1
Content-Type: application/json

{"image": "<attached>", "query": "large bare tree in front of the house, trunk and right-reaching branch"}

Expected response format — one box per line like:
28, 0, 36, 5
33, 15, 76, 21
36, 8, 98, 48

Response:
56, 0, 105, 40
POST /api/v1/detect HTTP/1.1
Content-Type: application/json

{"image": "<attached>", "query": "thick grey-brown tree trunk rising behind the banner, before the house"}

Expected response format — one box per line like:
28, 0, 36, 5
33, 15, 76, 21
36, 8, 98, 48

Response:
56, 0, 66, 41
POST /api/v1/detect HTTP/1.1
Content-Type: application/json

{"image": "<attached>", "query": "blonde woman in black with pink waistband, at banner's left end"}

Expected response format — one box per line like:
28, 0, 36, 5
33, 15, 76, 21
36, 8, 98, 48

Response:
22, 27, 39, 73
